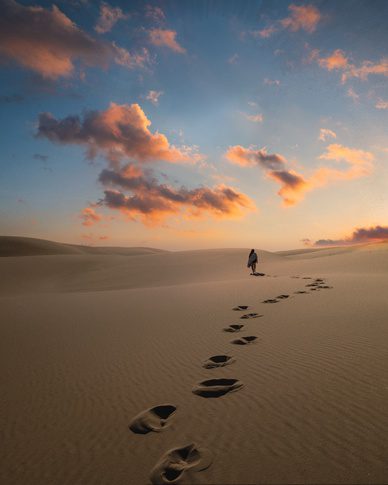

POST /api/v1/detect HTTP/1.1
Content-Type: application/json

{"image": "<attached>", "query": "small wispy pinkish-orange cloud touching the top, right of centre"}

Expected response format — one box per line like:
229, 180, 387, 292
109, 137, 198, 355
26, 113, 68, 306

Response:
252, 3, 322, 39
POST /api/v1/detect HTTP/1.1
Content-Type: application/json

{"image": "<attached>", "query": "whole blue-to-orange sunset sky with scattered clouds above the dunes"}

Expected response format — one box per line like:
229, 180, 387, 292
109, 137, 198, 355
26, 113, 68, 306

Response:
0, 0, 388, 250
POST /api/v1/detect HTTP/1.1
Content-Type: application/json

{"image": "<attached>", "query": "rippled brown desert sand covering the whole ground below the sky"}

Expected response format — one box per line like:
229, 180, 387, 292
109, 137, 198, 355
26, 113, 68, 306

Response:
0, 238, 388, 485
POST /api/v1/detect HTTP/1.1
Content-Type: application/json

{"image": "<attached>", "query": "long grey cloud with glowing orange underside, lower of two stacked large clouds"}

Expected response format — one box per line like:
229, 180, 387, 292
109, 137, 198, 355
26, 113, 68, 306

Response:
98, 164, 254, 225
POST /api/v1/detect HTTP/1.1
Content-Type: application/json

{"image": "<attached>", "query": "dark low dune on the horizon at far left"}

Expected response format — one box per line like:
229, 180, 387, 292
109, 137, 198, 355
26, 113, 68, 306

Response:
0, 236, 167, 257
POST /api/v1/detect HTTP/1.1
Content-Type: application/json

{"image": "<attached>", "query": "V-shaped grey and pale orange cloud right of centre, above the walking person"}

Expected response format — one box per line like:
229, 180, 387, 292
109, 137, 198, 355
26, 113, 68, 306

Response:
225, 144, 374, 206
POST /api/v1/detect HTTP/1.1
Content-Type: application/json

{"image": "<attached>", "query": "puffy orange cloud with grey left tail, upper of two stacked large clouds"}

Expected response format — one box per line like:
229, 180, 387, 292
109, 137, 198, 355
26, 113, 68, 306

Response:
37, 103, 194, 163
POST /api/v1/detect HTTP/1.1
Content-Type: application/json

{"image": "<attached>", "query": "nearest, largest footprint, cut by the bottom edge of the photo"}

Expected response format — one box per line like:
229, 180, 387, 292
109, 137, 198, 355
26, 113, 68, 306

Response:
150, 443, 213, 485
